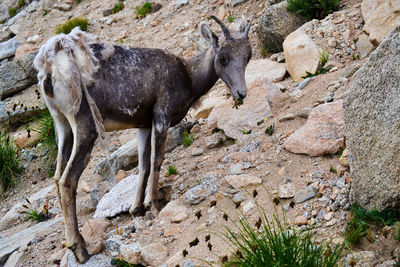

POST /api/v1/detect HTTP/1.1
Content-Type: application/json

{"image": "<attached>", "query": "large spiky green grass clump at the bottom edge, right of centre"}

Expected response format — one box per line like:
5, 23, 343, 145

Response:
223, 211, 344, 267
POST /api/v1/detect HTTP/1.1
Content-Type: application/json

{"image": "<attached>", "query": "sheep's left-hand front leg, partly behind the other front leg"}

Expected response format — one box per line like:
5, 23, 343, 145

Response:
129, 129, 151, 216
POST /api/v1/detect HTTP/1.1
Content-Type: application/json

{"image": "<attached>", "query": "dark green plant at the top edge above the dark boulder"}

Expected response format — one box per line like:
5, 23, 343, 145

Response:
286, 0, 339, 20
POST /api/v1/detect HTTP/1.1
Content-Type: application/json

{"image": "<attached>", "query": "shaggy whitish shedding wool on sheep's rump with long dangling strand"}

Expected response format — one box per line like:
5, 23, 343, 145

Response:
33, 27, 115, 180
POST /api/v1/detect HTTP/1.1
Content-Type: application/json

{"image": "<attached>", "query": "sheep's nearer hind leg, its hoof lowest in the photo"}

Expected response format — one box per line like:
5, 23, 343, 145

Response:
59, 119, 97, 263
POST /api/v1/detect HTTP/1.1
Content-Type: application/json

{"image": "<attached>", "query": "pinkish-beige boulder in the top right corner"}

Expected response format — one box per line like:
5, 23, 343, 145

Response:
363, 0, 400, 46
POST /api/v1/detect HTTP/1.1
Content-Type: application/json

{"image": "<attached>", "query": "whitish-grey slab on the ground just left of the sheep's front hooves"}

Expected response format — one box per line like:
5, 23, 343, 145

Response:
93, 175, 139, 218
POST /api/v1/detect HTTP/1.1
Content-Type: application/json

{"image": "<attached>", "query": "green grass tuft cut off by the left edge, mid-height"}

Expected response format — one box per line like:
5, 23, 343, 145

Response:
0, 132, 22, 197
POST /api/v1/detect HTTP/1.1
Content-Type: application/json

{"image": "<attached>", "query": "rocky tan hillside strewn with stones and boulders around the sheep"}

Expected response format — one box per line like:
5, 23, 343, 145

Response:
0, 0, 400, 267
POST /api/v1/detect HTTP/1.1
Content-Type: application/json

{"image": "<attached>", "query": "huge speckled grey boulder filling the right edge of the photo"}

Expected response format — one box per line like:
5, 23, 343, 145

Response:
344, 27, 400, 210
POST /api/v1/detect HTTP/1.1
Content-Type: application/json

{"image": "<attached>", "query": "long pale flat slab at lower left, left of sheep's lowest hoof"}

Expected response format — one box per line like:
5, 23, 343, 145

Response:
0, 217, 63, 265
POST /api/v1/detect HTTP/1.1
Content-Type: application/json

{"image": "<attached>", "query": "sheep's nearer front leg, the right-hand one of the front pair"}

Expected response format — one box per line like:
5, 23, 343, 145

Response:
144, 120, 169, 215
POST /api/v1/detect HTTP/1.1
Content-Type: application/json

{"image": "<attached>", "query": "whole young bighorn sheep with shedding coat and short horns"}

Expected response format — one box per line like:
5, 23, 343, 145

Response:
34, 16, 251, 263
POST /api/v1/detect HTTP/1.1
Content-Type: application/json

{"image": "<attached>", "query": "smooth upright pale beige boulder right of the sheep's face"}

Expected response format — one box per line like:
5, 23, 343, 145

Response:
283, 30, 320, 82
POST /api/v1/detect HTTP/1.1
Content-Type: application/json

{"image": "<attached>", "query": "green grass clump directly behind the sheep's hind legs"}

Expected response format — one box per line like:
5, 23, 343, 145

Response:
32, 110, 57, 176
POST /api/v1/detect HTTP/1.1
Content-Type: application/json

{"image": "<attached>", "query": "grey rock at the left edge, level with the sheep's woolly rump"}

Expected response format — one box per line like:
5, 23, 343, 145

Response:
0, 52, 37, 99
